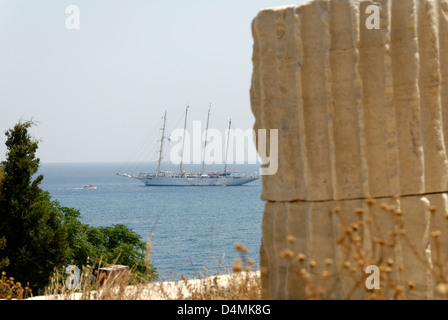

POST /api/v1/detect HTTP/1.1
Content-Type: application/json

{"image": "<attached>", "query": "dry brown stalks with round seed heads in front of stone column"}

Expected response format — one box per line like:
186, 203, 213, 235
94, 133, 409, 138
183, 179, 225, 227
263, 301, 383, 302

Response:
272, 197, 448, 300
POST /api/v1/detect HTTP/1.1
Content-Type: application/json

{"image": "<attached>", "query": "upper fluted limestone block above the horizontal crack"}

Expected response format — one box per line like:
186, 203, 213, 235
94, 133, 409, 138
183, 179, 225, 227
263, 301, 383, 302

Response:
251, 0, 448, 201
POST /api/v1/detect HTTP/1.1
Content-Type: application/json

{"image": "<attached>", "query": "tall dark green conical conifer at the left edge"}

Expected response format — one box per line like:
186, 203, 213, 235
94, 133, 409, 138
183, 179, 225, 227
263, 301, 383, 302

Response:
0, 121, 68, 290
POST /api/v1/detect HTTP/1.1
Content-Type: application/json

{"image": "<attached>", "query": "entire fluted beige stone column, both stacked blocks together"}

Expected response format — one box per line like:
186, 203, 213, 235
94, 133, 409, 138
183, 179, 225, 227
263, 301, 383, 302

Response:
250, 0, 448, 299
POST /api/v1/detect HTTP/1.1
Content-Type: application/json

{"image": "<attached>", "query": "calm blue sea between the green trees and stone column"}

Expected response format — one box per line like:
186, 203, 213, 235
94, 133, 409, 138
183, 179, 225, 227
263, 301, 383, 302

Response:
38, 163, 264, 280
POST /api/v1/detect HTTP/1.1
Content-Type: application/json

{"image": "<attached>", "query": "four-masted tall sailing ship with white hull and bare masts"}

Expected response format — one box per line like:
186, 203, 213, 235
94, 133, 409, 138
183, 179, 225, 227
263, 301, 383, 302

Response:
117, 106, 260, 186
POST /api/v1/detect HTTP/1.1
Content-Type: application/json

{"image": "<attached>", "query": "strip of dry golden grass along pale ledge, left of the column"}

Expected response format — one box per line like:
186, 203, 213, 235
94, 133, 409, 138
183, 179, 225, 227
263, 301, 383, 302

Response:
37, 240, 261, 300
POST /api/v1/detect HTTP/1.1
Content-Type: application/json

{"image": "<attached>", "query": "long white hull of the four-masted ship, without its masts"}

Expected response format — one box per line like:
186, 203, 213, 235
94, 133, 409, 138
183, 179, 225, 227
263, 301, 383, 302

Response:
134, 174, 259, 186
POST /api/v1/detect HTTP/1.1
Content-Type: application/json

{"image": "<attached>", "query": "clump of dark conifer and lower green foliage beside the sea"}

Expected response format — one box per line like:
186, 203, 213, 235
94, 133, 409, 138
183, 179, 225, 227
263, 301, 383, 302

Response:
0, 121, 157, 293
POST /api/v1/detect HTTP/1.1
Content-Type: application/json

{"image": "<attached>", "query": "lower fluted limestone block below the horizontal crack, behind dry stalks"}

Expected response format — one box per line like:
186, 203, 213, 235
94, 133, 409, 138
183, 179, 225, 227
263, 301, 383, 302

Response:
260, 193, 448, 299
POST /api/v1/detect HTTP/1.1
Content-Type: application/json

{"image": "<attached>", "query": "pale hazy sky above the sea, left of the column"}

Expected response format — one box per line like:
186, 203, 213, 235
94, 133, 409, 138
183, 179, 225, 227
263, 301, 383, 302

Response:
0, 0, 301, 162
